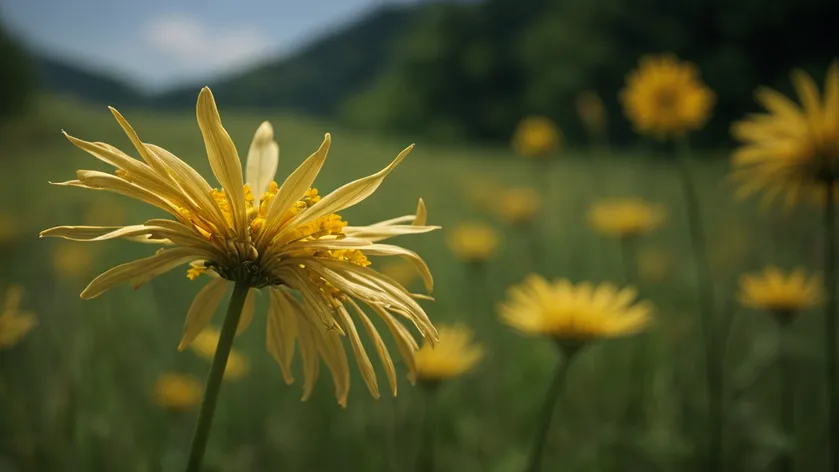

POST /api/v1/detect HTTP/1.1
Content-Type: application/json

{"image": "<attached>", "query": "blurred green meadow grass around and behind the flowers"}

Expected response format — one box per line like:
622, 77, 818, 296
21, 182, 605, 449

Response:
0, 98, 826, 472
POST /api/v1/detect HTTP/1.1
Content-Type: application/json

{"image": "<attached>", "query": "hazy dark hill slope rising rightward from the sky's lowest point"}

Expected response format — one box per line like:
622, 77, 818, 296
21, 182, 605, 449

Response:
152, 5, 423, 116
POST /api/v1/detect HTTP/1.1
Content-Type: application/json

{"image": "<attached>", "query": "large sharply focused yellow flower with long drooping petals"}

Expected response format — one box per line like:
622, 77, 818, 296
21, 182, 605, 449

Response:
41, 88, 438, 406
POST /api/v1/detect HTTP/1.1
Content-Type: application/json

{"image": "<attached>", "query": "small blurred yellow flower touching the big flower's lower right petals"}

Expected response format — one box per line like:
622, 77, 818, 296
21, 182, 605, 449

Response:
415, 324, 484, 382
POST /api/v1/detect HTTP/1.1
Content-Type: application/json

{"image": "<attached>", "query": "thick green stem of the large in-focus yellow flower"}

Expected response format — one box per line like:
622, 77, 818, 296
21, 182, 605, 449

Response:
186, 281, 250, 472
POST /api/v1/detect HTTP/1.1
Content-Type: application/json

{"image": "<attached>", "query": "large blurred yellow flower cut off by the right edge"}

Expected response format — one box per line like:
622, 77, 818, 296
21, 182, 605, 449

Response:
732, 60, 839, 206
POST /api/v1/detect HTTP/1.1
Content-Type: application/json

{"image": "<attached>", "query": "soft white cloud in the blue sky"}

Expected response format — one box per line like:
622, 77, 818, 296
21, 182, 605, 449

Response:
143, 16, 271, 75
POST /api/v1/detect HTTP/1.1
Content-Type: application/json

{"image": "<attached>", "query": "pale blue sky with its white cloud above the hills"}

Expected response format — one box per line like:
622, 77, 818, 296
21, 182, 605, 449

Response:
0, 0, 411, 89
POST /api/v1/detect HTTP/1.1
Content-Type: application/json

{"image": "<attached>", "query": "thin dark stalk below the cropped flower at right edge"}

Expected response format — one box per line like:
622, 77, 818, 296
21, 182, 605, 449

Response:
824, 179, 839, 472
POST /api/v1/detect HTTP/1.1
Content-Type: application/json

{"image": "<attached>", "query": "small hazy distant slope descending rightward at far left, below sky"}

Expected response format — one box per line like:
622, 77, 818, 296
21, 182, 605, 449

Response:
32, 54, 145, 106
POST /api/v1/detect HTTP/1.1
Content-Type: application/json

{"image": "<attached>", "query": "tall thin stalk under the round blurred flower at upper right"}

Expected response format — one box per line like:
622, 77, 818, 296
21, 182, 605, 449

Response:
676, 140, 723, 472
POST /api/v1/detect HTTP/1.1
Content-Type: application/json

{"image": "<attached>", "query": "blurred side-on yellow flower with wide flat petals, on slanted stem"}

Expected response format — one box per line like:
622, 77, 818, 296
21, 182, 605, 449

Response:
499, 275, 653, 343
